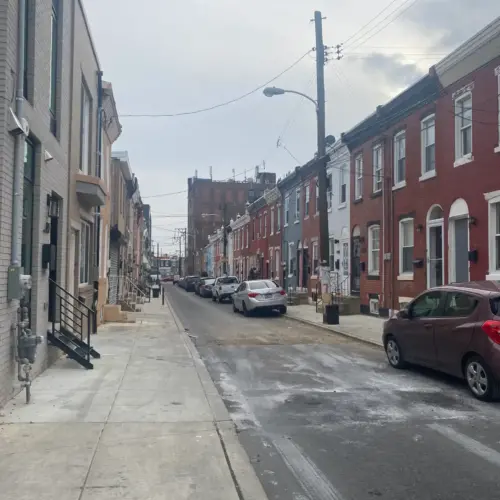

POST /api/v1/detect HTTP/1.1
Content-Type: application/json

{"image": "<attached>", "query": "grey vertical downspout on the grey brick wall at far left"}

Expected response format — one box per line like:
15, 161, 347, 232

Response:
9, 0, 26, 276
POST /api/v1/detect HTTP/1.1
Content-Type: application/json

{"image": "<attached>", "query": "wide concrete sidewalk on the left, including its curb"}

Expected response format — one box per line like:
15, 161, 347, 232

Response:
0, 299, 267, 500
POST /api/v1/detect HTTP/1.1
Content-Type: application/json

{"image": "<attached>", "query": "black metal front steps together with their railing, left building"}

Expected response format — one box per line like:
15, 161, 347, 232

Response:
48, 279, 100, 369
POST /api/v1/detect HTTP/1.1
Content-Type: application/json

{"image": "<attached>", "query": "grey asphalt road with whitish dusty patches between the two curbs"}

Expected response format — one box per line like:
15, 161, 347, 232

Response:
166, 285, 500, 500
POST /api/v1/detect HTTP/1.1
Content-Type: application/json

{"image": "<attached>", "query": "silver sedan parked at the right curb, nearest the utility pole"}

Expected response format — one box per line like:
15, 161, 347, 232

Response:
233, 280, 286, 316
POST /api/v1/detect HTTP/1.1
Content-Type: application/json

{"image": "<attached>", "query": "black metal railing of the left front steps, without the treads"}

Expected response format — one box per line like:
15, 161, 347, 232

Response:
49, 279, 97, 360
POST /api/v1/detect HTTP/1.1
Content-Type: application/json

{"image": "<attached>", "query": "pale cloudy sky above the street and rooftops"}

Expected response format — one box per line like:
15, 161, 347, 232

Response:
83, 0, 500, 252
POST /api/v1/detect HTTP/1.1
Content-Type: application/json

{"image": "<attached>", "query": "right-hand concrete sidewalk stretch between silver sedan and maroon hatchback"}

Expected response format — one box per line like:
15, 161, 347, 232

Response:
287, 305, 384, 346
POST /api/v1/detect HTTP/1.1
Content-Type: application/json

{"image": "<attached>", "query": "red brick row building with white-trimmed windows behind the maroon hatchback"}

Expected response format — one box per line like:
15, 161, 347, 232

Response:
343, 20, 500, 315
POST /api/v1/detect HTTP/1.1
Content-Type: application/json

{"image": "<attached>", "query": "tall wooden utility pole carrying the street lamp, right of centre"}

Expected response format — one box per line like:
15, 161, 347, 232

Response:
314, 11, 330, 280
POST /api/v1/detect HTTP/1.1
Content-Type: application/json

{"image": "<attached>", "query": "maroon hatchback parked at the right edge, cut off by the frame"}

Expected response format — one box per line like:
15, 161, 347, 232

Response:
383, 281, 500, 401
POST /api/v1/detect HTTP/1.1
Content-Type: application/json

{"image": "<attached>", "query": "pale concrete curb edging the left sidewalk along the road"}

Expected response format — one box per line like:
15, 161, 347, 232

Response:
165, 295, 268, 500
